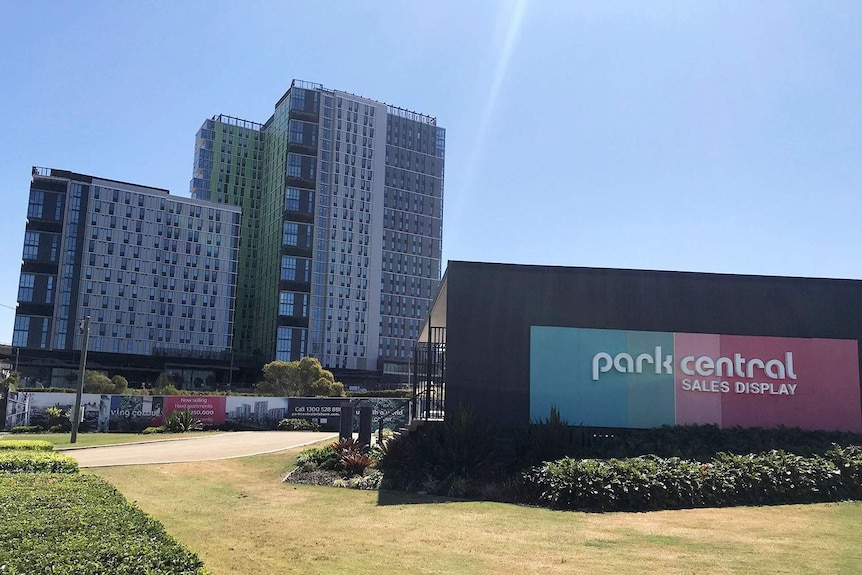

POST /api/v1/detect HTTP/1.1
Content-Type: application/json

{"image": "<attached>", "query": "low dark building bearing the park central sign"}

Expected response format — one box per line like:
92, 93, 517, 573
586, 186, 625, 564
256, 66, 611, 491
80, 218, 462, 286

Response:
416, 262, 862, 432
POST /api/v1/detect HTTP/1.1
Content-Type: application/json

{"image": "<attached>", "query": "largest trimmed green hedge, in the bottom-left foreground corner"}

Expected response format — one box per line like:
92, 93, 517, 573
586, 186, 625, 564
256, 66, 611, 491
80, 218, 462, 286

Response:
0, 474, 207, 575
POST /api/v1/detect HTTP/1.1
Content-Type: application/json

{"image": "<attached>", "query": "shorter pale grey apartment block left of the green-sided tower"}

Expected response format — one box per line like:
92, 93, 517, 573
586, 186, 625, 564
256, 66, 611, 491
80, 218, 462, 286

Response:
12, 167, 241, 386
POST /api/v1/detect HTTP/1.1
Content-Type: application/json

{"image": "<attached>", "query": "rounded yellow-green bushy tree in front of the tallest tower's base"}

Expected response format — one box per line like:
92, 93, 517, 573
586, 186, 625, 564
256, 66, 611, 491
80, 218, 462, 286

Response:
257, 357, 344, 397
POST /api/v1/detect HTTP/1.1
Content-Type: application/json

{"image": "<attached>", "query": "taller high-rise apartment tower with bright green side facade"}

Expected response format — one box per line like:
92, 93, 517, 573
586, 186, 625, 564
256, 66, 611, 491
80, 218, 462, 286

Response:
190, 80, 445, 381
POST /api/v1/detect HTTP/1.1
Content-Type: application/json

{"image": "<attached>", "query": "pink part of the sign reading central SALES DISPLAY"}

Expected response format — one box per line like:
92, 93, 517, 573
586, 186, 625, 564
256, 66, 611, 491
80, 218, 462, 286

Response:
674, 333, 862, 432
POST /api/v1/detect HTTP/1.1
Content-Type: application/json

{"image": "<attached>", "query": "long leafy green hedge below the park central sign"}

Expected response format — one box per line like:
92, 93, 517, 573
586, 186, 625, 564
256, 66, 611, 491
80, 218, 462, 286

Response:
519, 446, 862, 511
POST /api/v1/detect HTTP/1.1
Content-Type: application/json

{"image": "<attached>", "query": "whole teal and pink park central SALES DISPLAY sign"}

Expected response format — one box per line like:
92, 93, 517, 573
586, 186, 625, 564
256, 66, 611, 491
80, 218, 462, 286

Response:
530, 326, 862, 432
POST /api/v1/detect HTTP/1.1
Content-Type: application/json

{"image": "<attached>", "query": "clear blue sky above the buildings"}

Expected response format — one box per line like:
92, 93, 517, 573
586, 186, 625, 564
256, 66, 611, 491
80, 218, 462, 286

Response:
0, 0, 862, 342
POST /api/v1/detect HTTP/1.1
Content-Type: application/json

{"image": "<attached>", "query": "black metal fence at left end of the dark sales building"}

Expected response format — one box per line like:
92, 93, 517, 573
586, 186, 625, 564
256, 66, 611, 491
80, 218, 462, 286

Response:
410, 327, 446, 419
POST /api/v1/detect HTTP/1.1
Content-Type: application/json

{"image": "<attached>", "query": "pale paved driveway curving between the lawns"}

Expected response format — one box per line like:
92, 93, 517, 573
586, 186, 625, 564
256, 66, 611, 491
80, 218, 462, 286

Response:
63, 431, 338, 467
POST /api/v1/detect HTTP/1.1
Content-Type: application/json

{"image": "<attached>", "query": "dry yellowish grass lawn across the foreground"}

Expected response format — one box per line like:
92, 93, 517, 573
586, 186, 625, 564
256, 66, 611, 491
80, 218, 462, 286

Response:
93, 451, 862, 575
